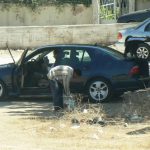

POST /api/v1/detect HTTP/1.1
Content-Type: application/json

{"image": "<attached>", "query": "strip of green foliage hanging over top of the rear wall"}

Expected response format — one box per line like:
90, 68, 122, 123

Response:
0, 0, 92, 8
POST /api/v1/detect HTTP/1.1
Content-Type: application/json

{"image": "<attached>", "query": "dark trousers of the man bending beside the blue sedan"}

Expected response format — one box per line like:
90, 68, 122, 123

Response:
50, 80, 63, 110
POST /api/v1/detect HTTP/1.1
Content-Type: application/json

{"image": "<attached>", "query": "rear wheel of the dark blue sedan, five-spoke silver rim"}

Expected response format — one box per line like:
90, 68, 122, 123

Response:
87, 78, 112, 103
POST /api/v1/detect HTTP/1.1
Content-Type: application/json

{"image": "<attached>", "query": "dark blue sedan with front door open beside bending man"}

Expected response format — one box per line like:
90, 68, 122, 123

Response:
0, 44, 149, 102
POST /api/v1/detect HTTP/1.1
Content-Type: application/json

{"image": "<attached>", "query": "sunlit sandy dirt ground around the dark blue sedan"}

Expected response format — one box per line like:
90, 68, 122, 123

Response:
0, 51, 150, 150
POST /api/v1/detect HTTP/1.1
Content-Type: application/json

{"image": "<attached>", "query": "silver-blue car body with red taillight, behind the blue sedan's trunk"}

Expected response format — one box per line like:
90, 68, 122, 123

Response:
115, 18, 150, 53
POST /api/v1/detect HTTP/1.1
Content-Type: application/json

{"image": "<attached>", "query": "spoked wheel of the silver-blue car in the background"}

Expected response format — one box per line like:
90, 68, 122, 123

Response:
136, 44, 150, 59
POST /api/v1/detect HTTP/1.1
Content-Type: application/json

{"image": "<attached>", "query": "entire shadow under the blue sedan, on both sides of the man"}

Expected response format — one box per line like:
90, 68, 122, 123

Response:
0, 98, 122, 120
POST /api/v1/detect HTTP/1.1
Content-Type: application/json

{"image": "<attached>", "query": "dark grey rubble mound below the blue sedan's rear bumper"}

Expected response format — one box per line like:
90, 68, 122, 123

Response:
122, 88, 150, 122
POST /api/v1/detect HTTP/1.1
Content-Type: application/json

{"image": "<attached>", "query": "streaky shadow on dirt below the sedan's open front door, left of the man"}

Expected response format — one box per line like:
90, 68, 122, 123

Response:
0, 98, 62, 119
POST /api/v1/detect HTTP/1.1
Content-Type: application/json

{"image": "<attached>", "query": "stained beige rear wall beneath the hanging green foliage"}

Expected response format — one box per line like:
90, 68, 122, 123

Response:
0, 4, 93, 26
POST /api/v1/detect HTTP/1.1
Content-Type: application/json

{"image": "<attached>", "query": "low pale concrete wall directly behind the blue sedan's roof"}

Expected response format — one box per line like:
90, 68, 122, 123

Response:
0, 24, 136, 49
